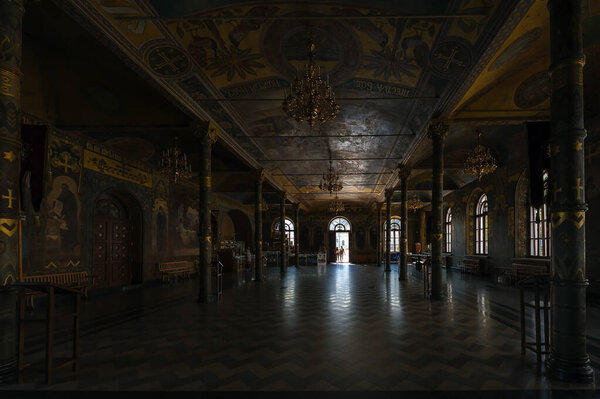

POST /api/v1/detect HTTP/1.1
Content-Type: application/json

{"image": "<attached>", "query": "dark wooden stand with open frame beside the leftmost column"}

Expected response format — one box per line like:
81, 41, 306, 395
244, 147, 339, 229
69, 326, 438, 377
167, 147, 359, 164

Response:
12, 282, 82, 384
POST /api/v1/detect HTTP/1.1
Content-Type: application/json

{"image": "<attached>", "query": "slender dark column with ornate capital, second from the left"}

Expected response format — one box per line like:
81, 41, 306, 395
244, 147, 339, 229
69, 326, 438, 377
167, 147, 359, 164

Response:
194, 122, 217, 302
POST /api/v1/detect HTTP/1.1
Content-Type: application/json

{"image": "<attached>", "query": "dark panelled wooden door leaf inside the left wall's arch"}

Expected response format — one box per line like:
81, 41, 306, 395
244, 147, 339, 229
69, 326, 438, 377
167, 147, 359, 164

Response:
94, 200, 133, 288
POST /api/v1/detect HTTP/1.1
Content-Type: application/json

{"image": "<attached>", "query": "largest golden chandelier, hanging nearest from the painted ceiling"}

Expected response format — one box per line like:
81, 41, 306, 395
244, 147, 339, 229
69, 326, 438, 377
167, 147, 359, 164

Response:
282, 42, 340, 128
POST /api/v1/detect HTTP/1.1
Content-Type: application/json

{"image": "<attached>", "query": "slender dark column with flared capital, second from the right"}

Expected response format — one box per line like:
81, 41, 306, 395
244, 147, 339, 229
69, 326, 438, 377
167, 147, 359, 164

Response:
428, 121, 448, 299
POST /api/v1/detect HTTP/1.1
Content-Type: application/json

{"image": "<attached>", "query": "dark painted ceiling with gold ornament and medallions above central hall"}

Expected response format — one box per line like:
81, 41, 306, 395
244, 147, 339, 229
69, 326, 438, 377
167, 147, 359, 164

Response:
63, 0, 536, 211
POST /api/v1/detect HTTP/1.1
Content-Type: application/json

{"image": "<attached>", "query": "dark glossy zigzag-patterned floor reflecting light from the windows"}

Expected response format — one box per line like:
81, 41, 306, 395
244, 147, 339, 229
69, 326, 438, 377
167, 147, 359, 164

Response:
0, 265, 600, 395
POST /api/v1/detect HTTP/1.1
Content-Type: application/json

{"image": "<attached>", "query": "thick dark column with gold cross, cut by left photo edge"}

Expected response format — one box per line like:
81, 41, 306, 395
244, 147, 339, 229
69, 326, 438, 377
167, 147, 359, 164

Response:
0, 0, 24, 384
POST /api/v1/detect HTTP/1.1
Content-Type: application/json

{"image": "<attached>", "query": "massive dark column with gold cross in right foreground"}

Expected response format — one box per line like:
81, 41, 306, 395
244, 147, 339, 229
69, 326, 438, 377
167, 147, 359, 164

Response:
548, 0, 594, 382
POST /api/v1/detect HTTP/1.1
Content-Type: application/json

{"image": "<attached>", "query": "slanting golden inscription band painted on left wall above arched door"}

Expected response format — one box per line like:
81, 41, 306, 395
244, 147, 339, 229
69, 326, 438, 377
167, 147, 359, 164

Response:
83, 143, 152, 188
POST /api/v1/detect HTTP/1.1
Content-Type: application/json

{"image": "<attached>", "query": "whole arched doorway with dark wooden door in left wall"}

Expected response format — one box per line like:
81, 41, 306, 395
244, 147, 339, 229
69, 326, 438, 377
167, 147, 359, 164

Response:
93, 191, 142, 288
